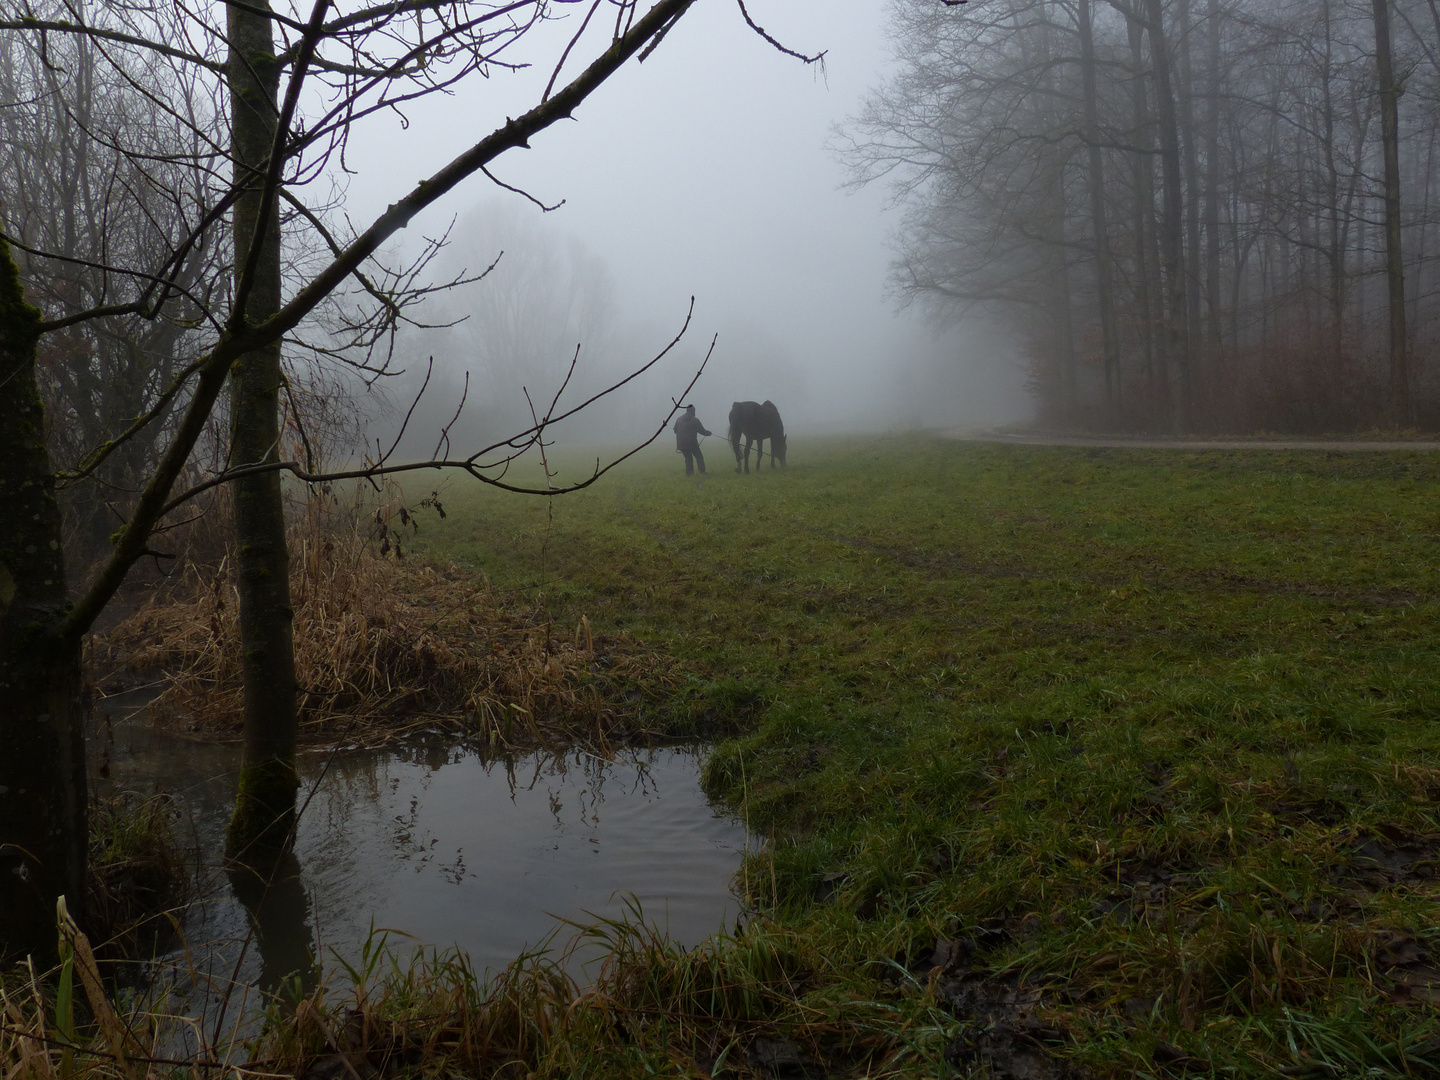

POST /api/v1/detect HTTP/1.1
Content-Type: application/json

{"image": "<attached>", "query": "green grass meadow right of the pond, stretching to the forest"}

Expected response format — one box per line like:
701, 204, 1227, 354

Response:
416, 436, 1440, 1077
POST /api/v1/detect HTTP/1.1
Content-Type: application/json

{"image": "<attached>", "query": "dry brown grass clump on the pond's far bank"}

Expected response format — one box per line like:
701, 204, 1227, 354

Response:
95, 514, 678, 749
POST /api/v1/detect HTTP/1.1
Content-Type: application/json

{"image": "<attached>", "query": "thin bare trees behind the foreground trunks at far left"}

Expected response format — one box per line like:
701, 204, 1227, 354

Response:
0, 25, 229, 570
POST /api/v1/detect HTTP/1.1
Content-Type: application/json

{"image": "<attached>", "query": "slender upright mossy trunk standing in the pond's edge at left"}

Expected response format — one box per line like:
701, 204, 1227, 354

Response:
225, 0, 300, 867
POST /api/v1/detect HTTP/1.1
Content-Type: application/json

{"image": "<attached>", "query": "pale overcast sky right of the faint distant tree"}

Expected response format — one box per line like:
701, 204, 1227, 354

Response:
347, 0, 1027, 432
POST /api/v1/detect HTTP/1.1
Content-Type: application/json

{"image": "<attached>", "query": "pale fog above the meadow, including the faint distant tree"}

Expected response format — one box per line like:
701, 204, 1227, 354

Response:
357, 0, 1030, 454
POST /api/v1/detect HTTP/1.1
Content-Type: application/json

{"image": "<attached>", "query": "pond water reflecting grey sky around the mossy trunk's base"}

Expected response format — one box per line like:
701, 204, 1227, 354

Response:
96, 711, 746, 989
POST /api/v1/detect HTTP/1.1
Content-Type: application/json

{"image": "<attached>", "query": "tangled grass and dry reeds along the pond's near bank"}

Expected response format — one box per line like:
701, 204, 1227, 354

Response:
0, 901, 921, 1080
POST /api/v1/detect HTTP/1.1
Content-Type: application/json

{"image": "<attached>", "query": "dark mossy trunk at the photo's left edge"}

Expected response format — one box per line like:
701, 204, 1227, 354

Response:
0, 238, 86, 963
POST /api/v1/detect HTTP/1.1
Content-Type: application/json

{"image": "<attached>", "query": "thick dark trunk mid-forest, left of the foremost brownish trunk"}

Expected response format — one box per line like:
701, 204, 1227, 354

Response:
1145, 0, 1191, 431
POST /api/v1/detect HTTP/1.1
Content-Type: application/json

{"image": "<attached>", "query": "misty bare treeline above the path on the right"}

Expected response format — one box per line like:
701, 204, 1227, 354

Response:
842, 0, 1440, 432
